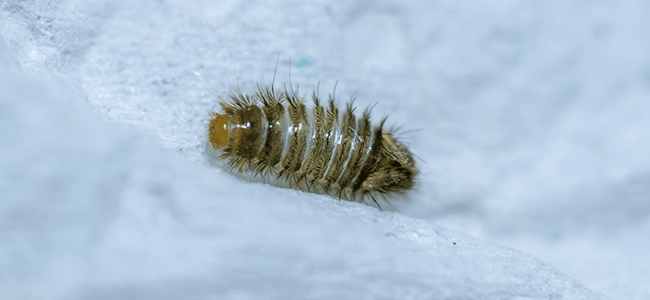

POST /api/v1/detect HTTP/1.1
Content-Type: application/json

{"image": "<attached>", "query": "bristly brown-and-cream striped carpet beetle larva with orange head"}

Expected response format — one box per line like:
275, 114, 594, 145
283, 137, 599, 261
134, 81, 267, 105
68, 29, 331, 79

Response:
207, 86, 418, 208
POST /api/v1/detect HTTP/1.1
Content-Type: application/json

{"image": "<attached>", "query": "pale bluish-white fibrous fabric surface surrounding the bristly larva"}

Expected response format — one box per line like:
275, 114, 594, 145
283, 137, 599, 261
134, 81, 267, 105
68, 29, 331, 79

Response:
0, 0, 650, 300
